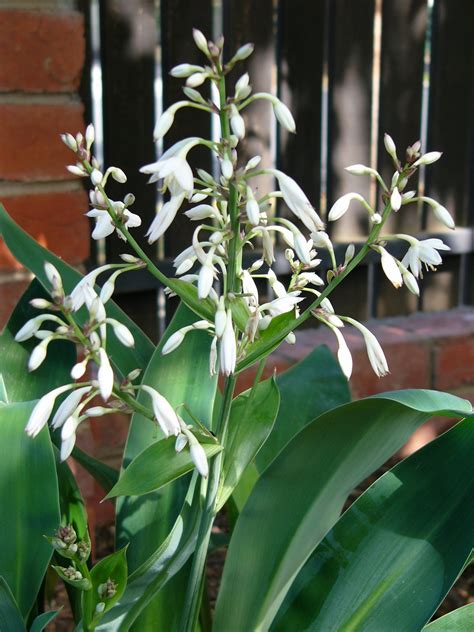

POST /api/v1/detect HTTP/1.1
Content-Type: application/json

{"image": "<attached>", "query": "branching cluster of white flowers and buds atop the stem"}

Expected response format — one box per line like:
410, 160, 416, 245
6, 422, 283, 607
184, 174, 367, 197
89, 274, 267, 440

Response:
17, 30, 454, 476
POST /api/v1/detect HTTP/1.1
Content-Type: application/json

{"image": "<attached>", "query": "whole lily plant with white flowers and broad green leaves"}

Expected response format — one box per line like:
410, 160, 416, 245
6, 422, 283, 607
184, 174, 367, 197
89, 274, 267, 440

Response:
0, 30, 474, 632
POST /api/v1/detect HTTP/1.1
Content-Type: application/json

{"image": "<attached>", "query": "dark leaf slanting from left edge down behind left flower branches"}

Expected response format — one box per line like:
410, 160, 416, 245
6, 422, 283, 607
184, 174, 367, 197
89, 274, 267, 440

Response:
0, 204, 154, 375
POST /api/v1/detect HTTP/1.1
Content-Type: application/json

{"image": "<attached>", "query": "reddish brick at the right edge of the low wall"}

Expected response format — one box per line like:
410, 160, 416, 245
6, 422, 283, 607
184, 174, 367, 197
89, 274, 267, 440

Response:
434, 336, 474, 391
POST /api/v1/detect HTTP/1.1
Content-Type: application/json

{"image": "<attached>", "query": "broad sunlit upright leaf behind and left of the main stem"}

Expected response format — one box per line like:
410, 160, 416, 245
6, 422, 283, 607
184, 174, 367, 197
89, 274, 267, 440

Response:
117, 305, 217, 631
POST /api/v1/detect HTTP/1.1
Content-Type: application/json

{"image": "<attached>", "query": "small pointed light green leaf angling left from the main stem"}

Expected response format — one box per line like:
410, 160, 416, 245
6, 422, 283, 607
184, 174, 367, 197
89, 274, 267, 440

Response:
106, 437, 222, 498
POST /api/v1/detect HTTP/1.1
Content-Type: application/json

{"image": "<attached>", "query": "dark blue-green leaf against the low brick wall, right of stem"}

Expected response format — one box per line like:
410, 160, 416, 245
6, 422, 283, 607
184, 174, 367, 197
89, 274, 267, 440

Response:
256, 346, 351, 472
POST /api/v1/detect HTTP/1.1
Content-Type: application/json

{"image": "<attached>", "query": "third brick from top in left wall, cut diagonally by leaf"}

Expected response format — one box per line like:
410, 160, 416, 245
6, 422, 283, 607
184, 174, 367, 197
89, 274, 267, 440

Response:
0, 189, 89, 269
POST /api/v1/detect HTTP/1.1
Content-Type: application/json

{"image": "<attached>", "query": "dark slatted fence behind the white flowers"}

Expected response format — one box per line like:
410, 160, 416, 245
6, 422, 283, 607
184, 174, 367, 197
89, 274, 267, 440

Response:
78, 0, 474, 335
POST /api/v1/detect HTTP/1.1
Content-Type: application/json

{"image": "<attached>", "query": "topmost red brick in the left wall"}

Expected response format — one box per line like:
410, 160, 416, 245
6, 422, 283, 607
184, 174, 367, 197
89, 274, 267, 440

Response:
0, 10, 85, 92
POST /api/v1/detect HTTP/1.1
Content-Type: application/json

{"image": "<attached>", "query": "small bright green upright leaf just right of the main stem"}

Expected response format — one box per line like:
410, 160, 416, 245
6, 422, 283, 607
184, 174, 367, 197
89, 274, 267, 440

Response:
218, 378, 280, 509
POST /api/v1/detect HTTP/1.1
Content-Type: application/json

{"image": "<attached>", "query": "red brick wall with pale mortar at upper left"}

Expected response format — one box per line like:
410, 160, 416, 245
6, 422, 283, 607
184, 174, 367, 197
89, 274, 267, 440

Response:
0, 6, 89, 327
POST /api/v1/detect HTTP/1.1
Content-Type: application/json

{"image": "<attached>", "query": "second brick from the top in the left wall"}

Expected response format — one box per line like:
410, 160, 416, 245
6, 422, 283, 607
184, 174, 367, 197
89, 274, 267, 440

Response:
0, 102, 84, 181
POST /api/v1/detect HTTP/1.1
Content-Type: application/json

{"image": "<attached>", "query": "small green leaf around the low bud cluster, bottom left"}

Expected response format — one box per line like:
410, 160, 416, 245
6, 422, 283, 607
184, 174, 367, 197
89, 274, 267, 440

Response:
87, 547, 127, 613
